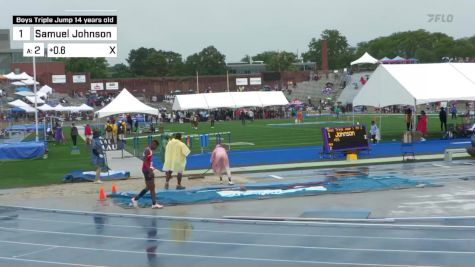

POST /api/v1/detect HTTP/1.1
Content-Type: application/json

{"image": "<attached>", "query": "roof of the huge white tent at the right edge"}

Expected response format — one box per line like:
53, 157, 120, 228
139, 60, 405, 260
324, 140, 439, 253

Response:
353, 63, 475, 107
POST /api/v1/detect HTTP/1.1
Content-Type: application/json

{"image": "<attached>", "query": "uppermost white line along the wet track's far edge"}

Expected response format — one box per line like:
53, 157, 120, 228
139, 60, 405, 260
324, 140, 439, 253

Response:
0, 205, 475, 229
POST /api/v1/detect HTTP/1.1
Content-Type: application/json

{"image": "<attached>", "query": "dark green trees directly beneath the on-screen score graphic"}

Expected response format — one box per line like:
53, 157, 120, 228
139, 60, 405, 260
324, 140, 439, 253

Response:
64, 57, 109, 78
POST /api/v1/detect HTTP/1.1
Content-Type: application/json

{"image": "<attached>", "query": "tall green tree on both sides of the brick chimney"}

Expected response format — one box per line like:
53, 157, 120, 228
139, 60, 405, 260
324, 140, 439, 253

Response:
303, 29, 352, 69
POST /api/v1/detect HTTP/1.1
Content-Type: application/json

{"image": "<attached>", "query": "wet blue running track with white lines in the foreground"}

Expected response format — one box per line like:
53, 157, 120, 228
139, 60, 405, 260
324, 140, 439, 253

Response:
0, 203, 475, 267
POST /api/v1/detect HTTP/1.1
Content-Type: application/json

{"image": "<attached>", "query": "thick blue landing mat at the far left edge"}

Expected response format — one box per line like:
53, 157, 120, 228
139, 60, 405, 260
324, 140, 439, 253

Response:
0, 142, 45, 160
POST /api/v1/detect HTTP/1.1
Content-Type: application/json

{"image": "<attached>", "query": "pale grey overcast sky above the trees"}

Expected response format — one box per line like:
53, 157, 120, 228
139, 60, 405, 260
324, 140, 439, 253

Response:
0, 0, 475, 64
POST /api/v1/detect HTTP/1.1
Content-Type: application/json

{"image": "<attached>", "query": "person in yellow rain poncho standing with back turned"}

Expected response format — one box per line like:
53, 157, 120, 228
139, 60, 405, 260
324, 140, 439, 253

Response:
163, 133, 190, 190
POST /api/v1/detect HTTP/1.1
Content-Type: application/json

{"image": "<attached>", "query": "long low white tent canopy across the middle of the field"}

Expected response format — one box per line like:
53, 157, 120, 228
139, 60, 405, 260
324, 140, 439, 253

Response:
172, 91, 289, 110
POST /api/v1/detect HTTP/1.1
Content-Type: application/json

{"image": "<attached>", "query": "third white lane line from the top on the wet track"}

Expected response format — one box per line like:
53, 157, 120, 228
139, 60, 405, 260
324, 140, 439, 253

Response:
0, 227, 475, 255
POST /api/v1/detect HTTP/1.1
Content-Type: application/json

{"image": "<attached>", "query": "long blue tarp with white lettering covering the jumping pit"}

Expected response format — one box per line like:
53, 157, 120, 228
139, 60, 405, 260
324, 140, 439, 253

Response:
110, 175, 432, 206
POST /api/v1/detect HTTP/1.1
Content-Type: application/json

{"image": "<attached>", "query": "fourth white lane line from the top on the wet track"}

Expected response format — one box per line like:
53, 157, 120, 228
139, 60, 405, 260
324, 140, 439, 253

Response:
0, 241, 438, 267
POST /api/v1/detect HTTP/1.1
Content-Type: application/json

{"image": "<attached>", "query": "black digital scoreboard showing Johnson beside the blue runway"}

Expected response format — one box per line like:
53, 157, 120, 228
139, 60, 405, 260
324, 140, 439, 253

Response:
322, 125, 369, 152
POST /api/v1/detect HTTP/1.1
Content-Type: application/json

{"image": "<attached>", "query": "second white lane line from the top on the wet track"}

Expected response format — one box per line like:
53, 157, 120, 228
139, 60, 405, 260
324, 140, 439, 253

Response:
0, 216, 475, 241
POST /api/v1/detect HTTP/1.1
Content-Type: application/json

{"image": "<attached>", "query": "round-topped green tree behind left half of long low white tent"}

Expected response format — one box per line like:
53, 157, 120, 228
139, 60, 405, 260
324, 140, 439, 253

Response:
185, 46, 227, 75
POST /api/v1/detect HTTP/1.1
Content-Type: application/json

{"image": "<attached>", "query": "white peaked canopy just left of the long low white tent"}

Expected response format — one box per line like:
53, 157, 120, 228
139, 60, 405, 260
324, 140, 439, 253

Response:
95, 88, 158, 118
